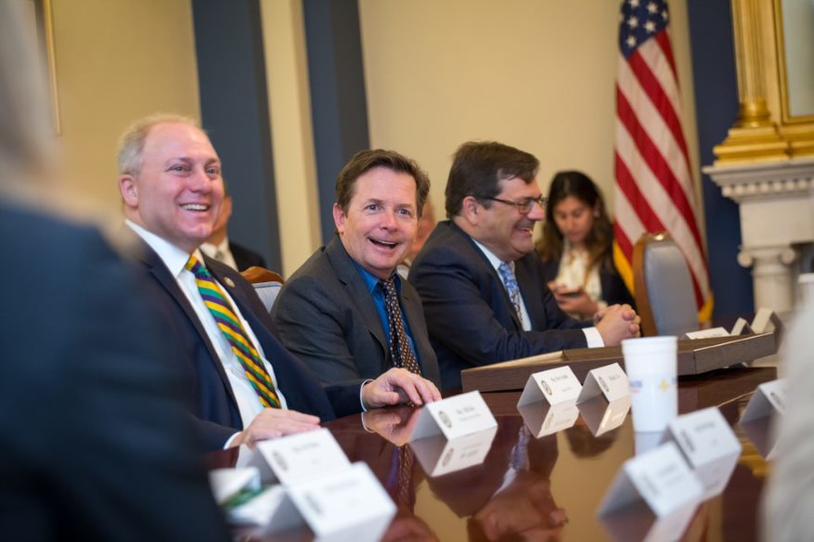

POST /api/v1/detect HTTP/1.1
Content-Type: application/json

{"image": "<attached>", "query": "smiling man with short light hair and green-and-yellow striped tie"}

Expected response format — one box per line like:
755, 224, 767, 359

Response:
119, 116, 436, 448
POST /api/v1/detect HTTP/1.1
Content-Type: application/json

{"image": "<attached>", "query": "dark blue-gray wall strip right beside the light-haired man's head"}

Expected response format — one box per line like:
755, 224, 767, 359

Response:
192, 0, 282, 270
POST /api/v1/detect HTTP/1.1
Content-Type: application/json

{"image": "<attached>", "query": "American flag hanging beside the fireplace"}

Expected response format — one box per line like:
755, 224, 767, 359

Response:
614, 0, 712, 321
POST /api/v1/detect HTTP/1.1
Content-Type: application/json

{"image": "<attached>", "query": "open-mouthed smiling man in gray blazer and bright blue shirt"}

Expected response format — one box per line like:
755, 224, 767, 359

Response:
271, 150, 440, 398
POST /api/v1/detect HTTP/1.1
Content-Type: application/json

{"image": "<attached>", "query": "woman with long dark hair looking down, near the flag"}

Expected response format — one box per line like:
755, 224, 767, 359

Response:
537, 171, 634, 319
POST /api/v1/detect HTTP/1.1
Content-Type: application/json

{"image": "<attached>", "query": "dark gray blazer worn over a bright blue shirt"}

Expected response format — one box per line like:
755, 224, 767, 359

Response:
272, 236, 440, 394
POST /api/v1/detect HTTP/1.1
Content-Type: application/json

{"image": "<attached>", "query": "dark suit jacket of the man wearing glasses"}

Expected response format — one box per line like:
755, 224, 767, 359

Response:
410, 221, 587, 389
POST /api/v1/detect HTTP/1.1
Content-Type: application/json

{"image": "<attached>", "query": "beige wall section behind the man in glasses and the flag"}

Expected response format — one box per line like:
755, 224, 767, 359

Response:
359, 0, 698, 223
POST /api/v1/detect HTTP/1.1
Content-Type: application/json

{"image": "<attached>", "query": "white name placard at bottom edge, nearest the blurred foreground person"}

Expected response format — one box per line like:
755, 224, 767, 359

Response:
286, 462, 396, 542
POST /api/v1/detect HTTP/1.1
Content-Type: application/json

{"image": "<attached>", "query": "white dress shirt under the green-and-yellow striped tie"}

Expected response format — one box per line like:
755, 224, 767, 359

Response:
126, 220, 287, 434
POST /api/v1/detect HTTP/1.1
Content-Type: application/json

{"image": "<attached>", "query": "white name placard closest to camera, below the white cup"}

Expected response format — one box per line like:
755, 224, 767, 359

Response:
599, 442, 703, 517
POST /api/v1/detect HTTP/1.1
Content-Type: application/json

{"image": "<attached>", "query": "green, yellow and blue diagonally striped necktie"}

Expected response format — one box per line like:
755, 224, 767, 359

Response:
185, 256, 280, 408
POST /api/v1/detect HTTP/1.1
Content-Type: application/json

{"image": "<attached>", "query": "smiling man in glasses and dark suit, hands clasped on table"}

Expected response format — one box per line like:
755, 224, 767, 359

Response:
409, 141, 639, 389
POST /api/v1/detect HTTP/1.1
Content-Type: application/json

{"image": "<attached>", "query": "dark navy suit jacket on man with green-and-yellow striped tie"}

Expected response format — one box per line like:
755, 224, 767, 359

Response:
131, 238, 342, 449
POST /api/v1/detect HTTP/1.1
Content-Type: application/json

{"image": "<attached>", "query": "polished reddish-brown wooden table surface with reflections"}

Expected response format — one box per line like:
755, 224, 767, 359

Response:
225, 368, 775, 541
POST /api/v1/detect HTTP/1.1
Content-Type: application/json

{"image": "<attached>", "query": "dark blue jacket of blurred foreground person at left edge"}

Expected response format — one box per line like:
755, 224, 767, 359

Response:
0, 202, 229, 541
